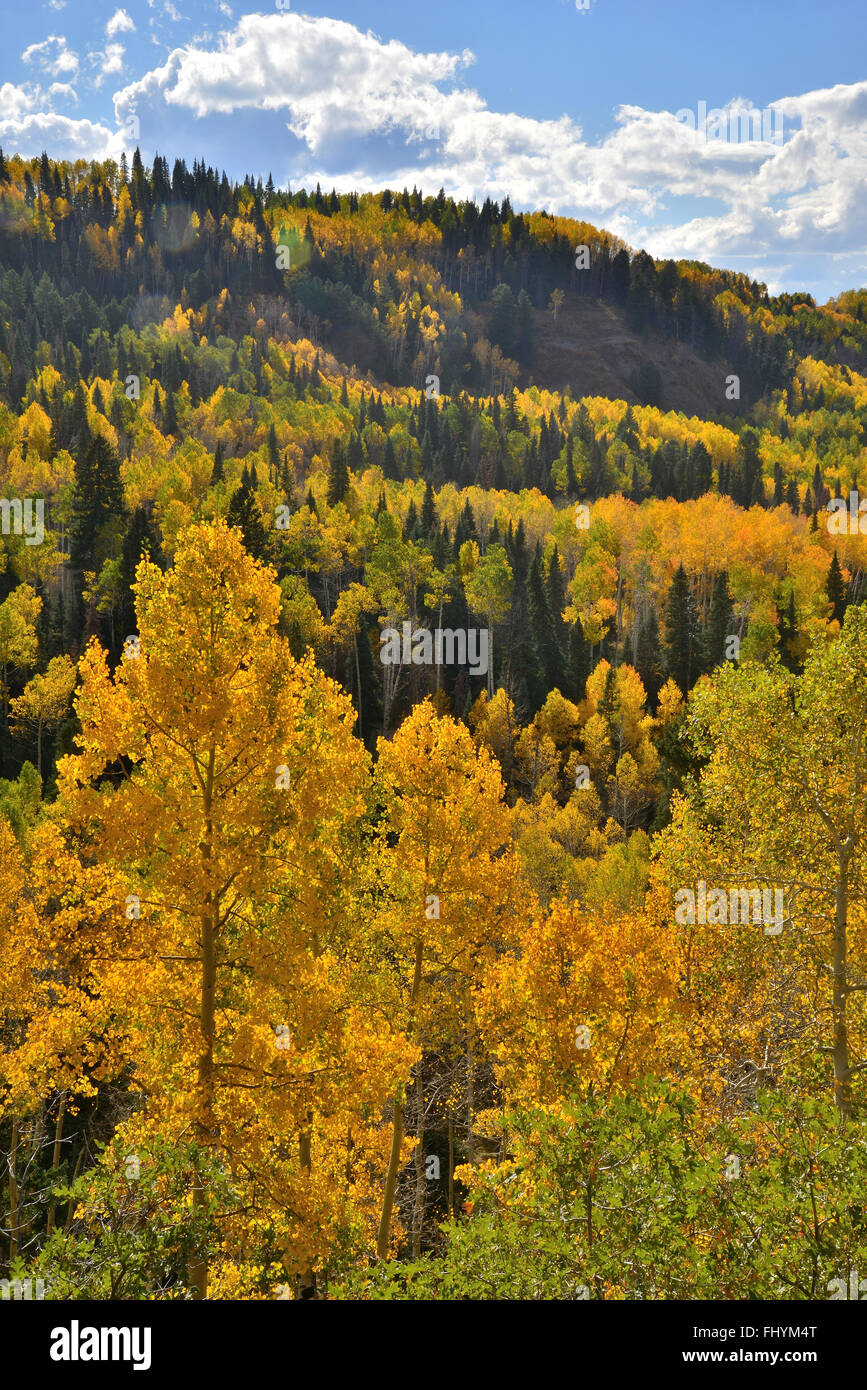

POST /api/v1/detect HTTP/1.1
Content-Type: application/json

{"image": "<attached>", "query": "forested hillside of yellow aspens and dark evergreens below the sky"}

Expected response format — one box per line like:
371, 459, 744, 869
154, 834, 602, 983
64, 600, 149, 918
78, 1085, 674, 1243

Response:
0, 150, 867, 1300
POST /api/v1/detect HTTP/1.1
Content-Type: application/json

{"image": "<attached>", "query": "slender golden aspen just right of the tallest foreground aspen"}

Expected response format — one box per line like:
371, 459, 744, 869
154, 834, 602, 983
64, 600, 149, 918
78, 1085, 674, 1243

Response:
377, 701, 517, 1258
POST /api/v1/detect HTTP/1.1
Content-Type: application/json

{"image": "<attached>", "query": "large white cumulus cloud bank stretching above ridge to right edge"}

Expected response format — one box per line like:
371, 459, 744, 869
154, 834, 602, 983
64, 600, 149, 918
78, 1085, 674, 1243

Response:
5, 9, 867, 296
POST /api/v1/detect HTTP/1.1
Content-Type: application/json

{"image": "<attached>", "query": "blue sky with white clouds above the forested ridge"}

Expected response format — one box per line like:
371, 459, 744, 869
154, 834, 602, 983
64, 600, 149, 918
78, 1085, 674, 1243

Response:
0, 0, 867, 303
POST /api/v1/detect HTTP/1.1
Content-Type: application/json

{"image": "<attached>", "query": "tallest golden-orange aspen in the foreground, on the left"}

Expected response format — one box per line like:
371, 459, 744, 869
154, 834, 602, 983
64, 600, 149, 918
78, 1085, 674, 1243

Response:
60, 523, 406, 1297
